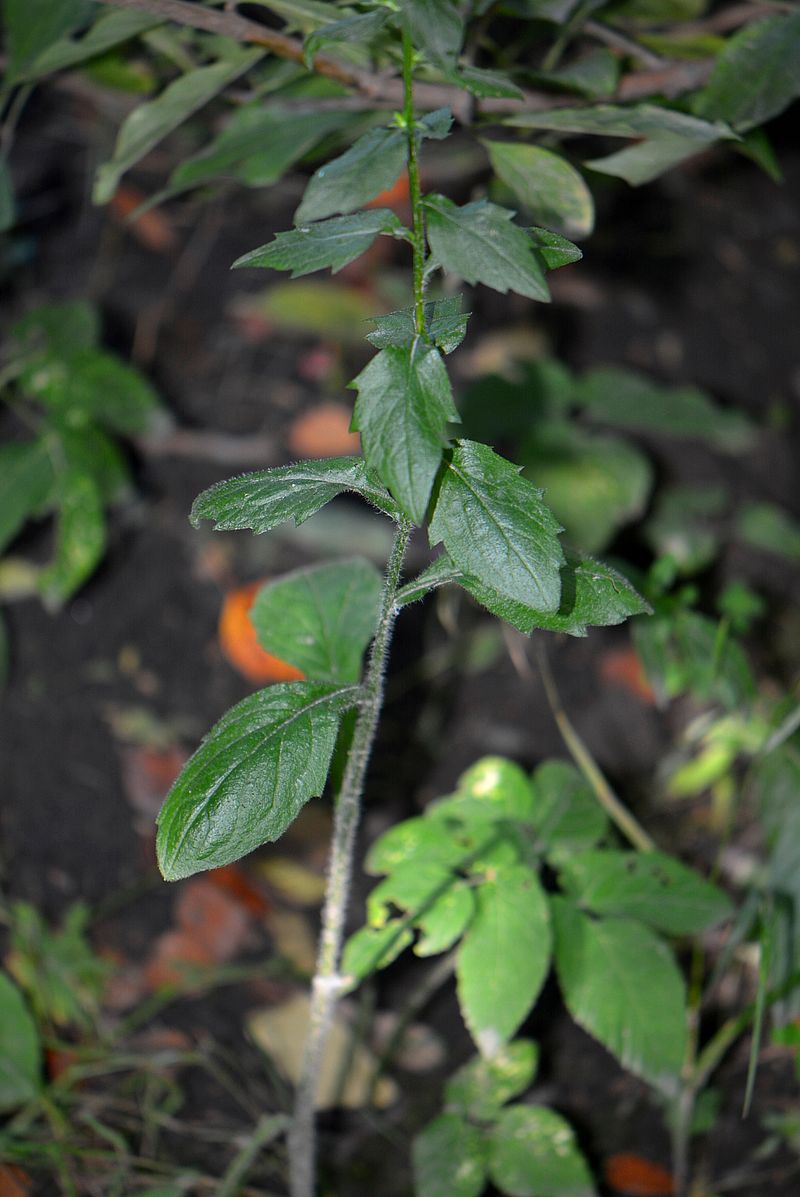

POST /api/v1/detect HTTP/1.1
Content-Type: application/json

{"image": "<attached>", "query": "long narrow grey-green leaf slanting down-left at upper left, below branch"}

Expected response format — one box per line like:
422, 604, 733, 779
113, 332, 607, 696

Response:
93, 49, 263, 203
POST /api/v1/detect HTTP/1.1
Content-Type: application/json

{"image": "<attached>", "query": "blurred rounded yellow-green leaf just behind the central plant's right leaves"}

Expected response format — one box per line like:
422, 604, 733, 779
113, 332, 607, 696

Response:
523, 421, 653, 553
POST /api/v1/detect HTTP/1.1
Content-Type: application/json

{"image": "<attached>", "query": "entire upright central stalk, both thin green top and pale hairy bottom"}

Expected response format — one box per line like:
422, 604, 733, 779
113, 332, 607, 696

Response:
289, 46, 425, 1197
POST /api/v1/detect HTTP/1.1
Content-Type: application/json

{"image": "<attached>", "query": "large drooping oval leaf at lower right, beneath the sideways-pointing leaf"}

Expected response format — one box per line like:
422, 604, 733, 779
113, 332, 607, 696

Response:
551, 898, 686, 1093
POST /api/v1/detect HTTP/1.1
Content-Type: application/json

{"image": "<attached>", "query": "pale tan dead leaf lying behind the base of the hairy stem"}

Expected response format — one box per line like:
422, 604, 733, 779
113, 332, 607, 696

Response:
247, 994, 398, 1110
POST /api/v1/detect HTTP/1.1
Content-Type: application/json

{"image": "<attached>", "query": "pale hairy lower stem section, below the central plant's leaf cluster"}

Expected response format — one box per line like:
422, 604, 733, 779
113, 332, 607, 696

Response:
289, 519, 411, 1197
